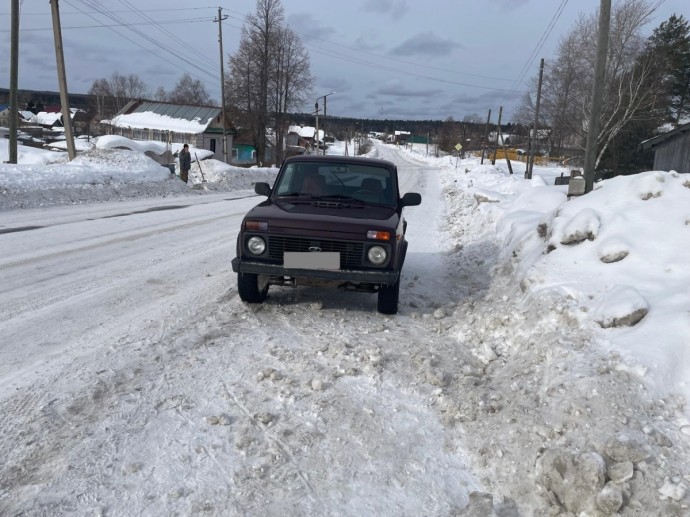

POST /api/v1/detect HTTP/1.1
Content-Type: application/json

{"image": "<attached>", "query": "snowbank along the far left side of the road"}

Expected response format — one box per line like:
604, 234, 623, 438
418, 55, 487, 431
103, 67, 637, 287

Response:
0, 136, 277, 210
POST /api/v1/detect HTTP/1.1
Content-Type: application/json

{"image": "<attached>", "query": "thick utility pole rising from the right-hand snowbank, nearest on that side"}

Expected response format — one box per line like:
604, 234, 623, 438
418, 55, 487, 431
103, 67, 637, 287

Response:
584, 0, 611, 193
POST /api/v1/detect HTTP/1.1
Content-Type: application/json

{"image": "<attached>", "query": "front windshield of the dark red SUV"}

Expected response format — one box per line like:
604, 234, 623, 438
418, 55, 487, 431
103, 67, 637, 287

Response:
273, 162, 397, 206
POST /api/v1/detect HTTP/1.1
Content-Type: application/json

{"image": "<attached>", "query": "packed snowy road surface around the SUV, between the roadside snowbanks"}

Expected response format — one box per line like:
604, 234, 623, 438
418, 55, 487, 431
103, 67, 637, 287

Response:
0, 151, 482, 515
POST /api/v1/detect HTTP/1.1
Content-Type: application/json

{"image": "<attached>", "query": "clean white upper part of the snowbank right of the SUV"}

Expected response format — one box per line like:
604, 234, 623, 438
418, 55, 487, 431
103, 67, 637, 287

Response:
404, 142, 690, 404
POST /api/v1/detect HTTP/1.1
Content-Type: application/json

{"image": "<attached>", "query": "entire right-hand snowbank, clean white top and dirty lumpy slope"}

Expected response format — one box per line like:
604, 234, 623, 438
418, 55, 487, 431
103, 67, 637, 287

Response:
398, 141, 690, 515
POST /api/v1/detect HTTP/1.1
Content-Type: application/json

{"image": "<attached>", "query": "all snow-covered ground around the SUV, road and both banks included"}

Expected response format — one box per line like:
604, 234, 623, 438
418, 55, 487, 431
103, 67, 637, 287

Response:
0, 136, 690, 516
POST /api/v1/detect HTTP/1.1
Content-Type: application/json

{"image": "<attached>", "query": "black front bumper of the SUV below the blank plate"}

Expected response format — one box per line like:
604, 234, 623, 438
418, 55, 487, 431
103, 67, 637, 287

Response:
232, 257, 400, 285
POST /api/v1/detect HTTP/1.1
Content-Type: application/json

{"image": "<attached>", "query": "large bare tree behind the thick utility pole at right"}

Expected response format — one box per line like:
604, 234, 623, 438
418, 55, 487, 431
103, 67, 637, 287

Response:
521, 0, 656, 167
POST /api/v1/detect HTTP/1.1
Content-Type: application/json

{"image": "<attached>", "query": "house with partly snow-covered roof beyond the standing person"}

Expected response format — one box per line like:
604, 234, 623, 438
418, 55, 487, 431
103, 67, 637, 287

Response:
101, 100, 235, 161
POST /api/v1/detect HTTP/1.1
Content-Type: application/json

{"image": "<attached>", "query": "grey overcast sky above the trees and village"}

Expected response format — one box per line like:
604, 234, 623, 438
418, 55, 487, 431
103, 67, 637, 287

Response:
0, 0, 690, 121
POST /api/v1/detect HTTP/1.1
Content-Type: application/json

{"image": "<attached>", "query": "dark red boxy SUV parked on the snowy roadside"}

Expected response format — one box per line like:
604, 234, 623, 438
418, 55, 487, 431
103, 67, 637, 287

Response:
232, 155, 422, 314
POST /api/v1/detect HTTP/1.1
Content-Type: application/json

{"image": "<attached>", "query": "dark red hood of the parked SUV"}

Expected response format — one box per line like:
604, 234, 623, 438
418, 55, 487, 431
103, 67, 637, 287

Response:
245, 200, 399, 235
